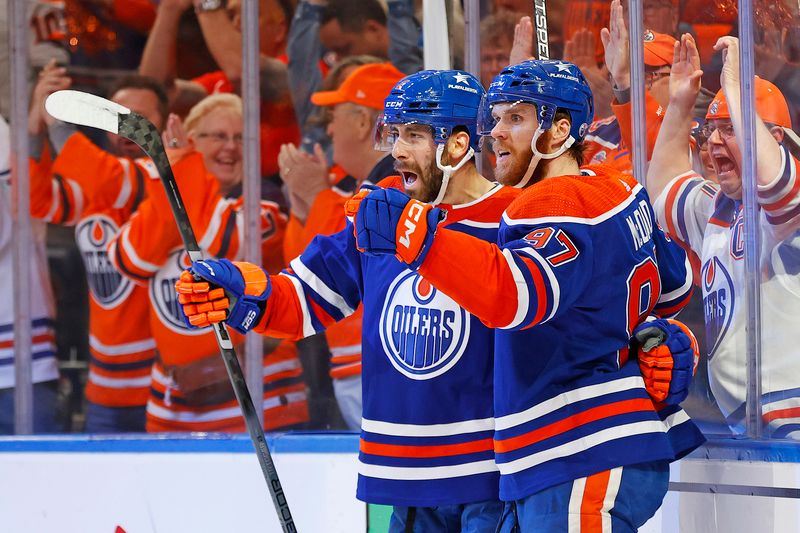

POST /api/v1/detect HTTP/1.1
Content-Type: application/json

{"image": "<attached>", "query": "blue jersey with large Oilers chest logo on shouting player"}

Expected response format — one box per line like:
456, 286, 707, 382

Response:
256, 180, 517, 507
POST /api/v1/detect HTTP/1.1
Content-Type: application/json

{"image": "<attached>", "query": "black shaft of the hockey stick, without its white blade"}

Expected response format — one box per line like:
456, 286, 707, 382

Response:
119, 113, 297, 533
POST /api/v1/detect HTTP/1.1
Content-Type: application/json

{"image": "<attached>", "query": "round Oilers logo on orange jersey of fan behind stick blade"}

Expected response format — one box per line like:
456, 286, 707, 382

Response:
75, 215, 133, 309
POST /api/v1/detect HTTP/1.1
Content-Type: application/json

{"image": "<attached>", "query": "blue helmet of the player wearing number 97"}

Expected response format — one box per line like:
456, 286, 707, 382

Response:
478, 59, 594, 143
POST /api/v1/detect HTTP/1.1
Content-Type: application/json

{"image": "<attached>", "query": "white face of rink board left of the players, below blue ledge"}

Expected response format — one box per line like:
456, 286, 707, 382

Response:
0, 436, 367, 533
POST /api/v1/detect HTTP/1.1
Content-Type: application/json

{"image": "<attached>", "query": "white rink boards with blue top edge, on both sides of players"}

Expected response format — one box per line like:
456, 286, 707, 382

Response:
0, 434, 800, 533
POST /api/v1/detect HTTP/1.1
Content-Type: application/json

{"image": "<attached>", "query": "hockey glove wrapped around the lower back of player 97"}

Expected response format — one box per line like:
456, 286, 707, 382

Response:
633, 318, 700, 405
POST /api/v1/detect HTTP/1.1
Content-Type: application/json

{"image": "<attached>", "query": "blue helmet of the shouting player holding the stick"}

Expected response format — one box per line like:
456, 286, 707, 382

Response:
375, 70, 485, 151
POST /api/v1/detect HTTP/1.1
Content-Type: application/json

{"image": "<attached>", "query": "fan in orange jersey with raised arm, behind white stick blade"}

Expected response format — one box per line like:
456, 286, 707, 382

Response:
29, 62, 167, 433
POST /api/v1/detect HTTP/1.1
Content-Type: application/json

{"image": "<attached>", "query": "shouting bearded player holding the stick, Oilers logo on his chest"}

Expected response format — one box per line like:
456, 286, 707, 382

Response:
178, 71, 518, 532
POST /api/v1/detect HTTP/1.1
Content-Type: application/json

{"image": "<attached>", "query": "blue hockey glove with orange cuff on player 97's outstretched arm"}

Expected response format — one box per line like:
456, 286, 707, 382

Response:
345, 189, 445, 269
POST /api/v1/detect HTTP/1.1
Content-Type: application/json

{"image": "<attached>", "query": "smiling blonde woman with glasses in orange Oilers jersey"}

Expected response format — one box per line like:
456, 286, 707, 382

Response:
109, 94, 308, 432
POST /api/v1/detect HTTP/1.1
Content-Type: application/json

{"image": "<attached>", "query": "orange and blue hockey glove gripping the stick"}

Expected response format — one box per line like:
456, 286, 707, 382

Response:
175, 259, 272, 334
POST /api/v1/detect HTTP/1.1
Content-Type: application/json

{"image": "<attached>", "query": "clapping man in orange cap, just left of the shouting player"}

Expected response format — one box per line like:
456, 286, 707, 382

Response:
278, 63, 403, 430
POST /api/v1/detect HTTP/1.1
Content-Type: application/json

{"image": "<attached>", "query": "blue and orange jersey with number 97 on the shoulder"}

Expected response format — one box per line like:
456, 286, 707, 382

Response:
420, 166, 703, 501
